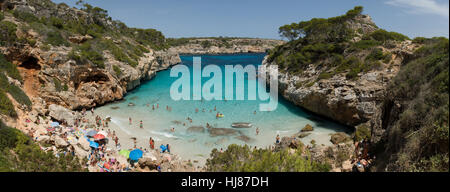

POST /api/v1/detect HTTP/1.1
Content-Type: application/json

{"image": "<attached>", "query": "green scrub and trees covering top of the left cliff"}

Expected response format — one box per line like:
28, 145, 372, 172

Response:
6, 1, 169, 68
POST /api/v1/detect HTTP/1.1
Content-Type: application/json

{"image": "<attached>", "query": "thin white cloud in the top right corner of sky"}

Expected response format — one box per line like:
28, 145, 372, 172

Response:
386, 0, 449, 19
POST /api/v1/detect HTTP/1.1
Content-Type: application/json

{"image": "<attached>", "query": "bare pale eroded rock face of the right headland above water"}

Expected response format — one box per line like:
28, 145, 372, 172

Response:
263, 41, 418, 134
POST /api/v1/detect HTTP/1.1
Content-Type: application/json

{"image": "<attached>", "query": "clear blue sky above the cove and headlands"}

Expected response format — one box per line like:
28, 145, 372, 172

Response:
53, 0, 449, 39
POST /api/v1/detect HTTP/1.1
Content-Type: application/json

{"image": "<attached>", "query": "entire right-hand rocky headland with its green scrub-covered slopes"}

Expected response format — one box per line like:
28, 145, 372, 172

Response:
263, 7, 449, 171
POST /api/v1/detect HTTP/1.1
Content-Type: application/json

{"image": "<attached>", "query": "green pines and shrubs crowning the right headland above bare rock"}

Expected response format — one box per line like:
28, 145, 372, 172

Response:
268, 7, 409, 84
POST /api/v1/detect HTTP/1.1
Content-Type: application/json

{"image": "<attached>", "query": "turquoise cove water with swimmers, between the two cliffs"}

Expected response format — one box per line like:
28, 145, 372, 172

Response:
96, 54, 348, 164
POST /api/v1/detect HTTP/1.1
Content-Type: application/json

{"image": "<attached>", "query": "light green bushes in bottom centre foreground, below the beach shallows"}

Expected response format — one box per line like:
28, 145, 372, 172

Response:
206, 144, 331, 172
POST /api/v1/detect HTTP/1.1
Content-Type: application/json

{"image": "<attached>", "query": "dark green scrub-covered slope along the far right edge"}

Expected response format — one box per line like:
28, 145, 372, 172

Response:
379, 38, 449, 172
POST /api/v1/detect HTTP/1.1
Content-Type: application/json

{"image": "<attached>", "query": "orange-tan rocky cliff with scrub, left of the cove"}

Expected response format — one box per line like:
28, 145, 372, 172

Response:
0, 0, 181, 118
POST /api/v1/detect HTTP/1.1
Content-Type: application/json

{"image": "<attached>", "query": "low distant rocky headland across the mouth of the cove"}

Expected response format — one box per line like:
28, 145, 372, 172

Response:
169, 38, 284, 54
